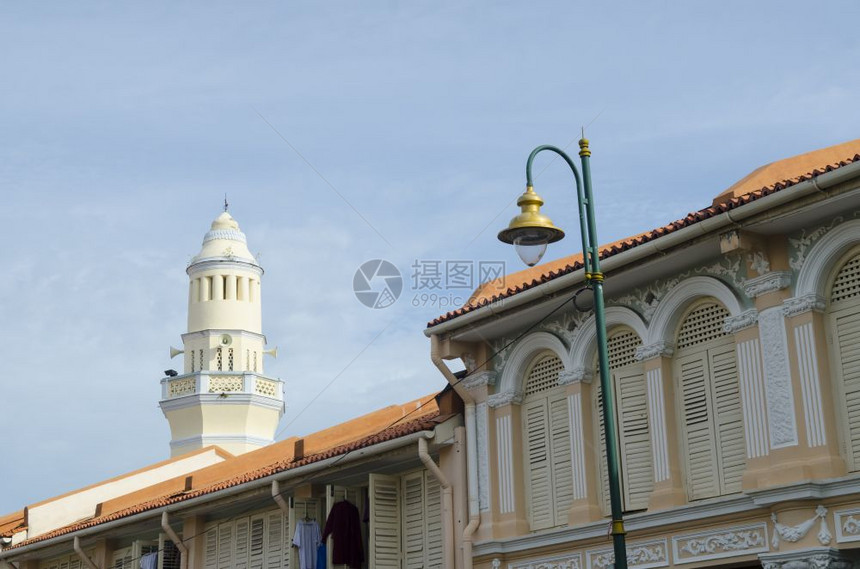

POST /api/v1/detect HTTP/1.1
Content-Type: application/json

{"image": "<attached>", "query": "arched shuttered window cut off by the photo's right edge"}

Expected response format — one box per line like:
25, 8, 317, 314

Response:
828, 249, 860, 470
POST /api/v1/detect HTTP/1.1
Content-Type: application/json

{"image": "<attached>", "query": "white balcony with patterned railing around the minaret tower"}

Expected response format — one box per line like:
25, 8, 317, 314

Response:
161, 370, 284, 401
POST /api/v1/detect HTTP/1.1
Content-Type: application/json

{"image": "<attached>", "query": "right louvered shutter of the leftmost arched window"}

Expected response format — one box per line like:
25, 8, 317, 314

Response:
547, 395, 573, 526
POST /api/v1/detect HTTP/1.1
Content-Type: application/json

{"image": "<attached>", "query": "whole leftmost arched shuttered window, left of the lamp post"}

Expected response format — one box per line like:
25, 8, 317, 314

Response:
521, 352, 573, 531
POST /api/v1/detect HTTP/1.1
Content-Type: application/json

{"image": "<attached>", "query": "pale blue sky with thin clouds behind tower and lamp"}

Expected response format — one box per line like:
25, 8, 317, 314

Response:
0, 1, 860, 512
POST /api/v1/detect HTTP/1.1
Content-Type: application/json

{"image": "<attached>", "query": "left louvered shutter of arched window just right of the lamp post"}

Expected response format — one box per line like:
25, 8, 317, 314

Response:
677, 351, 719, 500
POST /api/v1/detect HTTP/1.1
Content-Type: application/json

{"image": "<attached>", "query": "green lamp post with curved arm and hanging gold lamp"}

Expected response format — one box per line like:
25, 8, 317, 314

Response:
499, 138, 627, 569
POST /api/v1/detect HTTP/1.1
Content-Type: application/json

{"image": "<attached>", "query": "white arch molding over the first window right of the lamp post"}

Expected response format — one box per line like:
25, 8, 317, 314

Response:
642, 277, 742, 346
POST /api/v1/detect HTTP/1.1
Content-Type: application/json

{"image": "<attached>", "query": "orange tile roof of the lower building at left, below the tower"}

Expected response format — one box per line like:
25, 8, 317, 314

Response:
0, 398, 440, 549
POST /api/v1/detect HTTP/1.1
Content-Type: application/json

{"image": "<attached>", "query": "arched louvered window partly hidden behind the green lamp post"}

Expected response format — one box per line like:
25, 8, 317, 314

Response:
594, 326, 654, 513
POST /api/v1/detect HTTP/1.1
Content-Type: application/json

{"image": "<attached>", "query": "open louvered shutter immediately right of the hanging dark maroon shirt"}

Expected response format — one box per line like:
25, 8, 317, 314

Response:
368, 474, 401, 569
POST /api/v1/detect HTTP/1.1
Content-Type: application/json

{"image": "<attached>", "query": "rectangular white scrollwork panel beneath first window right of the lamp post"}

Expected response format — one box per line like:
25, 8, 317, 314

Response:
672, 523, 768, 565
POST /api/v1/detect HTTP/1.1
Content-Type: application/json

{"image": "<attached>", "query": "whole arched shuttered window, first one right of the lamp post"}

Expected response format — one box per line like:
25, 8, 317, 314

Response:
674, 298, 746, 500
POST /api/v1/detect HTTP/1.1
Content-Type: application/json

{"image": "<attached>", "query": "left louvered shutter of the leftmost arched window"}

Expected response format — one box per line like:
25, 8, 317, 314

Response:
522, 399, 555, 531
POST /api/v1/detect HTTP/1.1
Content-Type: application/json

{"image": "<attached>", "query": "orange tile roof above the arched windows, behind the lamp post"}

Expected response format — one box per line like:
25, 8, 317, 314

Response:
427, 139, 860, 328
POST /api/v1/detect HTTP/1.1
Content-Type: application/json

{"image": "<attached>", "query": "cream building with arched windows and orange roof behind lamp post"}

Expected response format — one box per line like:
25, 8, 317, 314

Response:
426, 140, 860, 569
